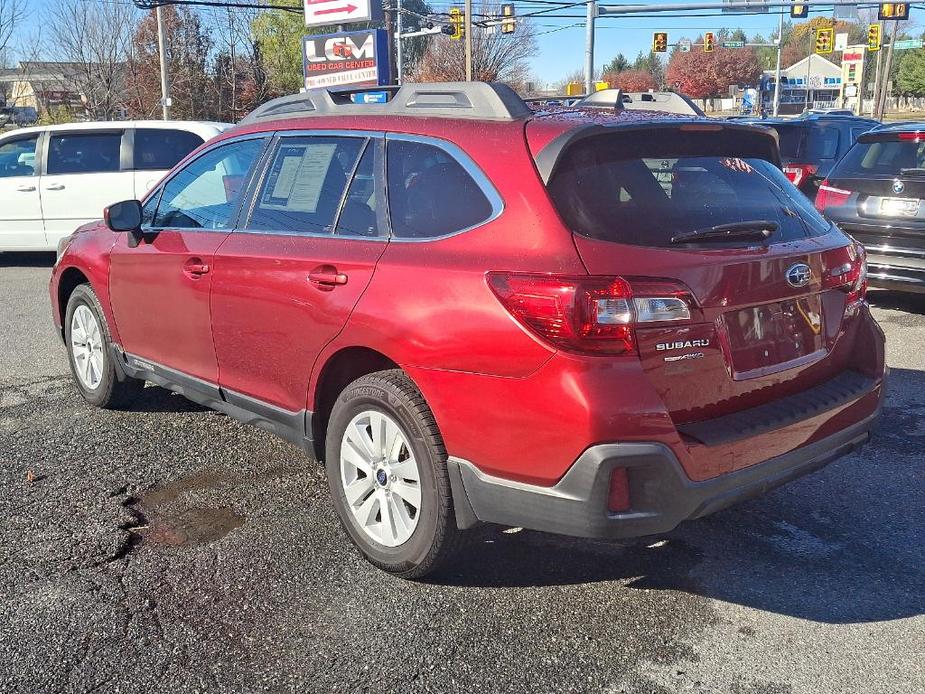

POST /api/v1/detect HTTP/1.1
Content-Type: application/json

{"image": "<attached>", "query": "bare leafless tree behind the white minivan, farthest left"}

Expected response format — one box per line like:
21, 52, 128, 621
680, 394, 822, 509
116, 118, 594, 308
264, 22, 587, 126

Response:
46, 0, 136, 120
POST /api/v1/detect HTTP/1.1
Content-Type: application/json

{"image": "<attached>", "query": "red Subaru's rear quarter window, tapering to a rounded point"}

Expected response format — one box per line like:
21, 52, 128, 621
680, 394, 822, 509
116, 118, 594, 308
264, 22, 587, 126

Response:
387, 140, 495, 239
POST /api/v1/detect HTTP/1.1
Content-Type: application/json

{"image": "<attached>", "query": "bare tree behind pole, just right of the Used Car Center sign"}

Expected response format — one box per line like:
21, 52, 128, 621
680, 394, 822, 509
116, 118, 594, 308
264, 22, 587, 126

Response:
411, 5, 537, 90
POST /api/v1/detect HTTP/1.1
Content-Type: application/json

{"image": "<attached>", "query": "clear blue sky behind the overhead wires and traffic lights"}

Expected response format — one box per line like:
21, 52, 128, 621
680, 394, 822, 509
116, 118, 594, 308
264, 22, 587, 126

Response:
16, 0, 922, 84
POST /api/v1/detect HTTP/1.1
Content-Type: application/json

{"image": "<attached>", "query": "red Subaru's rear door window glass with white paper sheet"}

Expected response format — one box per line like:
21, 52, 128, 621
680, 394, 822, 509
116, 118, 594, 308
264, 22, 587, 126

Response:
247, 136, 366, 234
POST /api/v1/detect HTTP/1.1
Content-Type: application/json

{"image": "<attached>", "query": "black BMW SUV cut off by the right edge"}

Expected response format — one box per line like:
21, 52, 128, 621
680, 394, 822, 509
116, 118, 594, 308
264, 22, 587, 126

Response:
816, 123, 925, 292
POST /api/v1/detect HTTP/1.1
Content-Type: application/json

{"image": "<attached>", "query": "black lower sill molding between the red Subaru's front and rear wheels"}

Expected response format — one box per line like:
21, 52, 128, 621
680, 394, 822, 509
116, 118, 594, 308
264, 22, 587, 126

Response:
112, 345, 314, 455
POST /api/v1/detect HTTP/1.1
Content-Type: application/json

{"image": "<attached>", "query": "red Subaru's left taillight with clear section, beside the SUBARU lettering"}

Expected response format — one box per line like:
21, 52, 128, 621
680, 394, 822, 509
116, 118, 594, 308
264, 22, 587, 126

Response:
488, 272, 692, 355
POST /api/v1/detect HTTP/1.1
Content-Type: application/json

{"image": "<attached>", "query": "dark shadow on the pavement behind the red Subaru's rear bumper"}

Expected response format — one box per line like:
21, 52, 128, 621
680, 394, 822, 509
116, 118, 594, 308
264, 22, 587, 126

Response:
434, 369, 925, 623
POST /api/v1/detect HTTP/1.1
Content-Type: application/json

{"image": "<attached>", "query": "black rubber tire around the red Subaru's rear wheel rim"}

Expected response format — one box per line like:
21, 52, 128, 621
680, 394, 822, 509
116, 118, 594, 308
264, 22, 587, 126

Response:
325, 369, 466, 578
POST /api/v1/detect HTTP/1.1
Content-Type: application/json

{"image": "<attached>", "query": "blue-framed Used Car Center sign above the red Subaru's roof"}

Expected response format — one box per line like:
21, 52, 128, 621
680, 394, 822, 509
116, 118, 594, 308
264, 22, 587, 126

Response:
302, 29, 391, 89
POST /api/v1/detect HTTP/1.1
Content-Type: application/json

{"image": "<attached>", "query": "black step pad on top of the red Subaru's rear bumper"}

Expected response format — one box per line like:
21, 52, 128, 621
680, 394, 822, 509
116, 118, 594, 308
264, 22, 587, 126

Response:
677, 371, 877, 446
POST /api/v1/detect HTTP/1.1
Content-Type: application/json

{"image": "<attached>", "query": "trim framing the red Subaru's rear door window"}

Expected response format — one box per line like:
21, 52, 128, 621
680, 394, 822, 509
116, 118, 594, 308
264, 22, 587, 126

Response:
234, 130, 392, 242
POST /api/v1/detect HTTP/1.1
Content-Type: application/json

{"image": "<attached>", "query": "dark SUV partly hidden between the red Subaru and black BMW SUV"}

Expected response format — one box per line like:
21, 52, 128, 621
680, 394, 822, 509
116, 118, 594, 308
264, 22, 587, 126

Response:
757, 114, 880, 200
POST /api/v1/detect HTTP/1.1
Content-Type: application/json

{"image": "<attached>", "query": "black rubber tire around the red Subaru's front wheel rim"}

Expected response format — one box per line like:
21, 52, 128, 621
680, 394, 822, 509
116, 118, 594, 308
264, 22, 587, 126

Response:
64, 284, 145, 410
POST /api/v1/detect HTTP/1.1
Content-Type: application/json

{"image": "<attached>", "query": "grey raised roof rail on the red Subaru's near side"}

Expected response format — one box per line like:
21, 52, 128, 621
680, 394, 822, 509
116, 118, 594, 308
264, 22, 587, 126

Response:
241, 82, 532, 125
